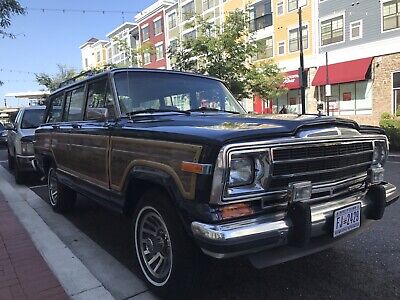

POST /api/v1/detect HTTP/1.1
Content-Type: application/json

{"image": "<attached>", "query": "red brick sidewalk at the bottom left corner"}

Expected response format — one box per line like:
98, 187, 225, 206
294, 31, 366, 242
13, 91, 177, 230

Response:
0, 193, 68, 300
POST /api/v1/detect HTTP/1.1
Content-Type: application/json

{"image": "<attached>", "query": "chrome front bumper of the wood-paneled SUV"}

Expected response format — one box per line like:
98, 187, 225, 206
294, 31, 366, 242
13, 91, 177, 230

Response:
191, 183, 399, 267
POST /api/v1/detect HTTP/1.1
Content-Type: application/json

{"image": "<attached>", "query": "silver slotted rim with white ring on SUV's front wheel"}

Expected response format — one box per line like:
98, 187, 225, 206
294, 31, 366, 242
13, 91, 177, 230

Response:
135, 206, 172, 286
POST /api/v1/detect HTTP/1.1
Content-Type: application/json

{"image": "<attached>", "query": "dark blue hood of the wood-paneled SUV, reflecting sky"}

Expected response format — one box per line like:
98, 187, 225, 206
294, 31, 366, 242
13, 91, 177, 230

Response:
116, 113, 360, 144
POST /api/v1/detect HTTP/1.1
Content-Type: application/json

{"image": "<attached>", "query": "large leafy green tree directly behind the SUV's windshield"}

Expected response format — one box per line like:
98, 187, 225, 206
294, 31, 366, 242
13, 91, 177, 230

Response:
168, 11, 285, 100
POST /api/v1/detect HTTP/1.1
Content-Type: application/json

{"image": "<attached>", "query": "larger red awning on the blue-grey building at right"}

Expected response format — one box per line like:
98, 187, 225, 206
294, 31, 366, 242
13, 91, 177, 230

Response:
312, 57, 373, 86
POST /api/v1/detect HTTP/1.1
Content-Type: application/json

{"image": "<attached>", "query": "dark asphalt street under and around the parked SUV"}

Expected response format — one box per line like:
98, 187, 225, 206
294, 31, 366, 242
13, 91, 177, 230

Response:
0, 145, 400, 299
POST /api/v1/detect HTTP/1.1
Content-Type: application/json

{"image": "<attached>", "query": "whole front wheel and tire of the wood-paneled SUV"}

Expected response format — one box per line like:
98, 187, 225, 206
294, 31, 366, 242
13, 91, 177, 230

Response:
133, 191, 202, 298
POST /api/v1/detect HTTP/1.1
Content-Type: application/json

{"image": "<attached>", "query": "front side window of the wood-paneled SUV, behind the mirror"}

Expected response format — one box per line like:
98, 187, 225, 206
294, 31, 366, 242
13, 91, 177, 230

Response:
85, 79, 115, 120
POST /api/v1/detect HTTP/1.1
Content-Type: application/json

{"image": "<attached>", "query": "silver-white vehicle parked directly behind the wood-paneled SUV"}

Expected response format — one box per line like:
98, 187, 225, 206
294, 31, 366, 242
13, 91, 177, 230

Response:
7, 106, 45, 184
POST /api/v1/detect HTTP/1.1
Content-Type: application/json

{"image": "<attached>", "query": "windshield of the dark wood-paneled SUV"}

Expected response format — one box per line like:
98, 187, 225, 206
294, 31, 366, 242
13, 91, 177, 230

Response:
114, 71, 246, 115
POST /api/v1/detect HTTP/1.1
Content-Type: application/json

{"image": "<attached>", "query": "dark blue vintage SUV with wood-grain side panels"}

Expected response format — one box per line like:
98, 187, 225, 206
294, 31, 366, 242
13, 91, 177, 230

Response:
35, 69, 398, 296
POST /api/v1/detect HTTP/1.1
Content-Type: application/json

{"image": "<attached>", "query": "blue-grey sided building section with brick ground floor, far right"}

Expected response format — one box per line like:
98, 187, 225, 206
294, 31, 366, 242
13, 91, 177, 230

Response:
312, 0, 400, 125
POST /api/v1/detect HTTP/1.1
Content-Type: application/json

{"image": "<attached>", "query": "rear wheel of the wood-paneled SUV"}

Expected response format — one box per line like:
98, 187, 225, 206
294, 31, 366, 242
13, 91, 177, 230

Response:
47, 166, 76, 213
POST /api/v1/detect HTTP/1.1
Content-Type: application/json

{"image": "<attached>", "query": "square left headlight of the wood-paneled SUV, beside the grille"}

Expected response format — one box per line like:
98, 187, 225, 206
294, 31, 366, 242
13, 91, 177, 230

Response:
228, 157, 254, 187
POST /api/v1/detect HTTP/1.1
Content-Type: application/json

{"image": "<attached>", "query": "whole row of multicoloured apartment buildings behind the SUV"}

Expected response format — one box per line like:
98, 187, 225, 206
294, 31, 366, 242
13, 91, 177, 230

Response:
81, 0, 400, 124
